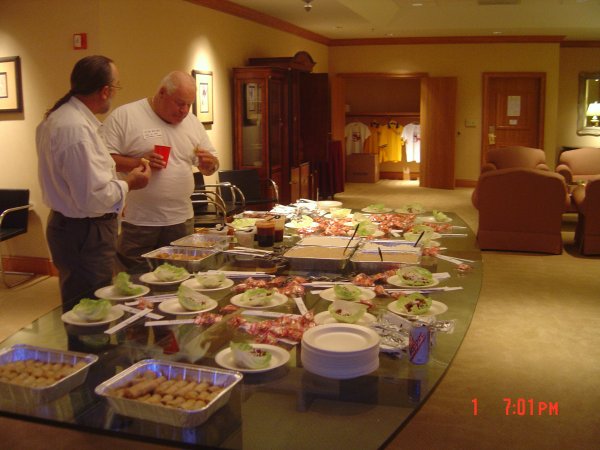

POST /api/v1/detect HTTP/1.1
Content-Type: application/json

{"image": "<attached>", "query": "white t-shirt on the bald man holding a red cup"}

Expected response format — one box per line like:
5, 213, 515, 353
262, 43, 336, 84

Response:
104, 99, 216, 226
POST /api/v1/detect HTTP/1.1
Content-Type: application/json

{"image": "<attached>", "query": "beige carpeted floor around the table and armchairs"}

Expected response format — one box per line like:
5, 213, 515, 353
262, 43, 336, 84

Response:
0, 180, 600, 450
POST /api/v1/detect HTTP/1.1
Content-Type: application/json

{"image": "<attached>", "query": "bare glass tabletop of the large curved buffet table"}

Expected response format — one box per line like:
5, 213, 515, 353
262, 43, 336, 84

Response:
0, 214, 482, 449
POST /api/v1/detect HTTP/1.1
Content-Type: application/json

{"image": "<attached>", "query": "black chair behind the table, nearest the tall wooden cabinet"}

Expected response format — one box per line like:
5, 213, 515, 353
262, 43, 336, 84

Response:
219, 169, 279, 209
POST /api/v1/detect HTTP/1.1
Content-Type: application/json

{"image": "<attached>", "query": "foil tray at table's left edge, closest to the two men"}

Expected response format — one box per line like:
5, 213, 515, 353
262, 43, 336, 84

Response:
142, 246, 223, 272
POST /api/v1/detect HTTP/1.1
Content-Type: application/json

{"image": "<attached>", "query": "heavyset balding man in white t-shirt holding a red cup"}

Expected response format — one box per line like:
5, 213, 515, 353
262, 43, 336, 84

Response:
104, 71, 219, 273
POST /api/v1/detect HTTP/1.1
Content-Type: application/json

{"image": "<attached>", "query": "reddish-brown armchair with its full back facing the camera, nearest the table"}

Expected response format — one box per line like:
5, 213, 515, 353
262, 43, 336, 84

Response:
473, 168, 570, 254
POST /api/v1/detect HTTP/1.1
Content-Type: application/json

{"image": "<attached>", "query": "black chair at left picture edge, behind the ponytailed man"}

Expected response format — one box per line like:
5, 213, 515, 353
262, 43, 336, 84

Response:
0, 189, 35, 288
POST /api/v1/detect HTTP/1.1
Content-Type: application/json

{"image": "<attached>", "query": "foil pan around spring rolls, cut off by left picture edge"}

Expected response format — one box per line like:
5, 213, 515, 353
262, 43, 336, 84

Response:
0, 344, 98, 404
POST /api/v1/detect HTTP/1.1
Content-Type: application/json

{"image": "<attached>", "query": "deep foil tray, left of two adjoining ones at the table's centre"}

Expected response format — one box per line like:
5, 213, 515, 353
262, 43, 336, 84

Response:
283, 245, 355, 272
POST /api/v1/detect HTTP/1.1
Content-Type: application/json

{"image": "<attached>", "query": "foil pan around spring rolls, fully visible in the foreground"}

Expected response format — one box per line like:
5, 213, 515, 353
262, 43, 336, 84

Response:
95, 359, 243, 428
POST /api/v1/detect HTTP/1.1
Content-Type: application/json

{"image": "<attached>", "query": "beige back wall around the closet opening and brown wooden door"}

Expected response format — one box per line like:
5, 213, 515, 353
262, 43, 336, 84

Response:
329, 44, 559, 181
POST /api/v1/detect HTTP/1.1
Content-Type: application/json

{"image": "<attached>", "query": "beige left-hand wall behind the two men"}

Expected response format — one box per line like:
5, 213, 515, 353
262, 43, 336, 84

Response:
0, 0, 328, 258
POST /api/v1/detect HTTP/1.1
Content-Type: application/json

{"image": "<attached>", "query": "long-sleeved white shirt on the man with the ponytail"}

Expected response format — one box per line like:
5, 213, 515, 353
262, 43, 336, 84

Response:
36, 97, 129, 218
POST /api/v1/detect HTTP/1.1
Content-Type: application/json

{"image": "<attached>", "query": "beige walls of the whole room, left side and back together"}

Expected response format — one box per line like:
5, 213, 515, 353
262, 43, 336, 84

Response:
0, 0, 600, 264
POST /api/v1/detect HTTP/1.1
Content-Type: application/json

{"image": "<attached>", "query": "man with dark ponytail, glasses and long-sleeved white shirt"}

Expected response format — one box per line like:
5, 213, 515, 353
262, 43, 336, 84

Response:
36, 55, 150, 310
